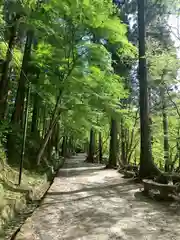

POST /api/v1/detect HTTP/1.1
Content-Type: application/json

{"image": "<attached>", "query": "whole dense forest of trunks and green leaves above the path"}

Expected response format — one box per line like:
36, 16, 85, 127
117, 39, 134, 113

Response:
0, 0, 180, 232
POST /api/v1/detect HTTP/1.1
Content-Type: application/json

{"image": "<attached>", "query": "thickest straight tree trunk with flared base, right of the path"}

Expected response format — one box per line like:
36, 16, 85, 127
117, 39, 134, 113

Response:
137, 0, 160, 178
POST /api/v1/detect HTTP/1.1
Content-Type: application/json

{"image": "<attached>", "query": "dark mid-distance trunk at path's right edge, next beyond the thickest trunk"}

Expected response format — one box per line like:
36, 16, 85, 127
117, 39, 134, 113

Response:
106, 118, 118, 168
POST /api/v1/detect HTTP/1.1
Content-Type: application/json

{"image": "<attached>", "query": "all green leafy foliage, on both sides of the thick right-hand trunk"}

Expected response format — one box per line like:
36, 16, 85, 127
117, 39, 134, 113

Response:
0, 0, 179, 185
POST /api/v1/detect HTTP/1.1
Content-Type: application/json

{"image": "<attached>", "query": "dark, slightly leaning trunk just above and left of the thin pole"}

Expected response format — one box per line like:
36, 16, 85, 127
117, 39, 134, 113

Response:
12, 30, 33, 126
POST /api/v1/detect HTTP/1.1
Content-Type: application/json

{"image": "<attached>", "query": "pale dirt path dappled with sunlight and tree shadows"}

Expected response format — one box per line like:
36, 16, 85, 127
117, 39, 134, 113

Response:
16, 155, 180, 240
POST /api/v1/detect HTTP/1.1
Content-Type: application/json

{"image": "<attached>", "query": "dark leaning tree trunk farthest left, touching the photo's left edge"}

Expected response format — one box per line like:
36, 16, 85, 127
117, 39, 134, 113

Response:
0, 20, 18, 120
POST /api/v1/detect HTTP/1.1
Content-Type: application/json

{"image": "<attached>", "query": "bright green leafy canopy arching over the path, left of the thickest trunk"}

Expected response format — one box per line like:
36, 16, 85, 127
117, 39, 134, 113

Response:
0, 0, 136, 166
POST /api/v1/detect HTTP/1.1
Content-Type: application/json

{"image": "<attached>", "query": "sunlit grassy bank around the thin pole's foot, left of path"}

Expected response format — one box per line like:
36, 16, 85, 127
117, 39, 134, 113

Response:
0, 144, 62, 236
